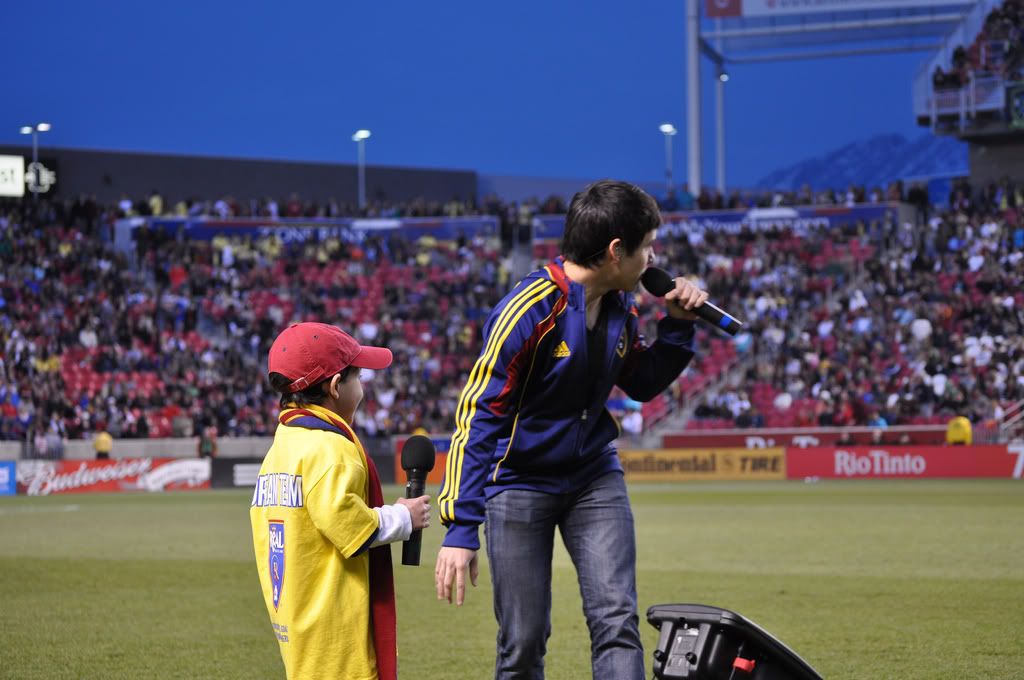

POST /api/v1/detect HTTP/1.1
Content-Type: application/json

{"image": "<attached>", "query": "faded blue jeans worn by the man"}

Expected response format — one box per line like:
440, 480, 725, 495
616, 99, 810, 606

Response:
484, 472, 644, 680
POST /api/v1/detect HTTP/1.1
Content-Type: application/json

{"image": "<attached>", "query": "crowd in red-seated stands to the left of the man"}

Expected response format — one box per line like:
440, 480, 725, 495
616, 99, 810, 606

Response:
0, 195, 520, 450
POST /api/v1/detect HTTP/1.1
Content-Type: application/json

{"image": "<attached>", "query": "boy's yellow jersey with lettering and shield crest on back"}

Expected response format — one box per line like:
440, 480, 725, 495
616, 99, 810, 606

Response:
249, 407, 378, 680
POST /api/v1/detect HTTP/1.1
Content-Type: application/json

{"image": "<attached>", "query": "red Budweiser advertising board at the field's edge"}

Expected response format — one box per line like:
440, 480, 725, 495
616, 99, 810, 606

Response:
17, 458, 210, 496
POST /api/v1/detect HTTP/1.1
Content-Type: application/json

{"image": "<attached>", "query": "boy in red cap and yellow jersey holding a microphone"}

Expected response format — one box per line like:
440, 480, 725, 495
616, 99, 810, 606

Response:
256, 323, 430, 680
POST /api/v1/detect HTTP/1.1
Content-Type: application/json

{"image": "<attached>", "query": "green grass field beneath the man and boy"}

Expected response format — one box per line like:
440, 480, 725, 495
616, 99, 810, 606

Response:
0, 480, 1024, 680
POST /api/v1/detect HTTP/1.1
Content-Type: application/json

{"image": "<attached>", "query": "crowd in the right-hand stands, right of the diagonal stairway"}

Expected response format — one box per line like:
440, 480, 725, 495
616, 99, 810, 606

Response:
691, 180, 1024, 428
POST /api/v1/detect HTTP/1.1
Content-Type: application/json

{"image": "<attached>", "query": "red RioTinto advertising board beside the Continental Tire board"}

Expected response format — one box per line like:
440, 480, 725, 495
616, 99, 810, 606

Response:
785, 444, 1024, 479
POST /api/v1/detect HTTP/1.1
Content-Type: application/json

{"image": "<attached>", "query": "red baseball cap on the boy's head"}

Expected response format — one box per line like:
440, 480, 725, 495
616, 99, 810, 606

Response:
267, 322, 391, 392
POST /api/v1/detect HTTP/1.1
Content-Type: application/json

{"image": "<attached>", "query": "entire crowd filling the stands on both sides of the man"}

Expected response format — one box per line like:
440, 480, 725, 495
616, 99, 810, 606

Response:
0, 175, 1024, 454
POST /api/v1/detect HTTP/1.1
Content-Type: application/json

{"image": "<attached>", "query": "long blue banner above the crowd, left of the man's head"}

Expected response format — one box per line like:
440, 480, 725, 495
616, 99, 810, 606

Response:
116, 215, 500, 249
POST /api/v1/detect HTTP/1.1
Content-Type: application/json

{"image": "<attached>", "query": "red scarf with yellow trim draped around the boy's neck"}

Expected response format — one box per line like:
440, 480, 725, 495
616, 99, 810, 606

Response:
280, 408, 398, 680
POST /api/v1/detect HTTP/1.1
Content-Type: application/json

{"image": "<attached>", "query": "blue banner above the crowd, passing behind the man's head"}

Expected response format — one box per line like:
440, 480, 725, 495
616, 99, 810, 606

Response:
534, 203, 901, 243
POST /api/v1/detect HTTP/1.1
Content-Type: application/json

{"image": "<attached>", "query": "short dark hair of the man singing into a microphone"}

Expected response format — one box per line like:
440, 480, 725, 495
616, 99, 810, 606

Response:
562, 179, 662, 268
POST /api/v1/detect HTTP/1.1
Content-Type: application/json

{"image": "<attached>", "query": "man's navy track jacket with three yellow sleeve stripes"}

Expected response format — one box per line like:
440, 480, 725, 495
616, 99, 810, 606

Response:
438, 258, 693, 550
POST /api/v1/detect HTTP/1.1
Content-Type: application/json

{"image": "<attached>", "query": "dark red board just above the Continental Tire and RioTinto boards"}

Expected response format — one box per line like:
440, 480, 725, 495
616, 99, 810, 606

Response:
662, 425, 946, 449
